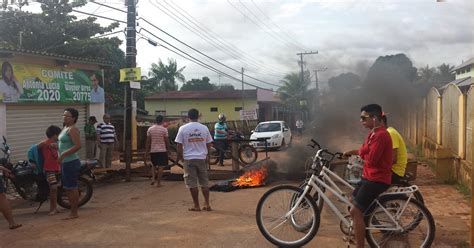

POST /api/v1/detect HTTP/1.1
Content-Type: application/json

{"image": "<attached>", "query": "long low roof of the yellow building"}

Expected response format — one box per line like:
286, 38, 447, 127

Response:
145, 90, 257, 100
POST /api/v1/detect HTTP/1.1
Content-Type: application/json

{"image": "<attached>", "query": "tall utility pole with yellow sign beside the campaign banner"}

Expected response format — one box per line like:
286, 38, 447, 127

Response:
124, 0, 137, 182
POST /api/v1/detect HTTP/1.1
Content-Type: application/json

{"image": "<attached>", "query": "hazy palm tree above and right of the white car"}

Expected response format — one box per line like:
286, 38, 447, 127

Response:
278, 71, 311, 109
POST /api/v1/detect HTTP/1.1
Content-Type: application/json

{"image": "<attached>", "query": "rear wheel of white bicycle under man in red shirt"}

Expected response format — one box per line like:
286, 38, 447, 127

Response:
365, 195, 436, 247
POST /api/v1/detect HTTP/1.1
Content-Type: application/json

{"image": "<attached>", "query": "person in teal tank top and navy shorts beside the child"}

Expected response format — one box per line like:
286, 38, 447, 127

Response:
58, 108, 81, 220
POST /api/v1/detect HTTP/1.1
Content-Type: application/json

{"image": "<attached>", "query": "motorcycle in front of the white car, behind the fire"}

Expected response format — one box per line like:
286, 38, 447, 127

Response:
209, 132, 258, 165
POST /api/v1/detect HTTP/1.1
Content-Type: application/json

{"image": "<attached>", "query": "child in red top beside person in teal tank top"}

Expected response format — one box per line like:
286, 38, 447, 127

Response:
38, 125, 61, 215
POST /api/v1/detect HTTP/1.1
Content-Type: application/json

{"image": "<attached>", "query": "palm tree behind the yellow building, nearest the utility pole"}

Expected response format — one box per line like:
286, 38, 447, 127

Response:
147, 58, 186, 92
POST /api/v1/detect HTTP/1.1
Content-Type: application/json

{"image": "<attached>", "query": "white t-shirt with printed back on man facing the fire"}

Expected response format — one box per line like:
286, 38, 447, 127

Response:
174, 122, 212, 160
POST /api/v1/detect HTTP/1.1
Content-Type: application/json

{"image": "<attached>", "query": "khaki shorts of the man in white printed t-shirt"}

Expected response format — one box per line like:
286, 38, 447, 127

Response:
183, 159, 209, 189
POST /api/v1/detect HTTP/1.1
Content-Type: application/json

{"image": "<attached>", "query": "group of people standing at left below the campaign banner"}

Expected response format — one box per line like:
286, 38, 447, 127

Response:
0, 108, 116, 229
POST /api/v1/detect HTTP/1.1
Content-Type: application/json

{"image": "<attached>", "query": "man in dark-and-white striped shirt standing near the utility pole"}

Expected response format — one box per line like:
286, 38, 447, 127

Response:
97, 114, 117, 168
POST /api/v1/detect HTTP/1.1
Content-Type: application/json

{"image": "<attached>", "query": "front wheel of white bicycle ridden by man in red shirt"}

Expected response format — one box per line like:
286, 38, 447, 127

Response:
256, 185, 320, 247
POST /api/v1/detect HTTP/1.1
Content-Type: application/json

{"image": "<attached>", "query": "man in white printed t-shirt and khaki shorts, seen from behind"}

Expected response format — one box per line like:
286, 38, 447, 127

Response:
175, 109, 212, 211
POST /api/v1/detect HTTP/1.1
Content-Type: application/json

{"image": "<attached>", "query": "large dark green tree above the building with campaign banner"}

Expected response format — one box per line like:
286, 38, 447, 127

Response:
0, 0, 125, 106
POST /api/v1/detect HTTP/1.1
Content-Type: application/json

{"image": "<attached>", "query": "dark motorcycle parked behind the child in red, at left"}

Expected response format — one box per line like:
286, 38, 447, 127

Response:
0, 137, 98, 213
